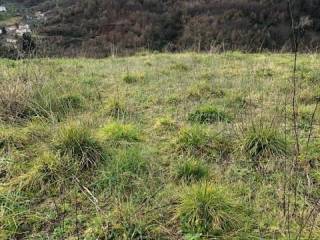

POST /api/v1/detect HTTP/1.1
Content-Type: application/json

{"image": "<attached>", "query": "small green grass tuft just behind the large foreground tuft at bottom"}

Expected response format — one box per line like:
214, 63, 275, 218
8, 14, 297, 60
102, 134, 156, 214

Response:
175, 159, 208, 182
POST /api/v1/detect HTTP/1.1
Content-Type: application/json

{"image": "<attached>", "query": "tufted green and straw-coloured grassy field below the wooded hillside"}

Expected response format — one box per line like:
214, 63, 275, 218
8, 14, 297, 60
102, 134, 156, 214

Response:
0, 52, 320, 240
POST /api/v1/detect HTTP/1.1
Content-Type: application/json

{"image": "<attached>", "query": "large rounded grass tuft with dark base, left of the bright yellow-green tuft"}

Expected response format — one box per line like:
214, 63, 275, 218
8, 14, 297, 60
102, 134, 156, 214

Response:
55, 125, 105, 169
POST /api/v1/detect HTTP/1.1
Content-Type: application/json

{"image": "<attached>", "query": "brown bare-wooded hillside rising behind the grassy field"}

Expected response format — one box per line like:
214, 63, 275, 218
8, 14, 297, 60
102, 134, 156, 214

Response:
15, 0, 320, 56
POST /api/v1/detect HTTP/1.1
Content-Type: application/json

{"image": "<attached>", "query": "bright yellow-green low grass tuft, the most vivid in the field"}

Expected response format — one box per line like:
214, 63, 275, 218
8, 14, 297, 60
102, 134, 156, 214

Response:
98, 122, 141, 144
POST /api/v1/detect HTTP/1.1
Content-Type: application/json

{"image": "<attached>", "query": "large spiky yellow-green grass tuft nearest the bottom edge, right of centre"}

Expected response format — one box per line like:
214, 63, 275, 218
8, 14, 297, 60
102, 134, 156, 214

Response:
177, 184, 249, 237
